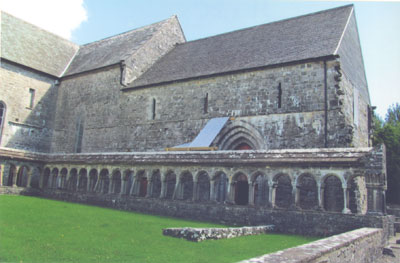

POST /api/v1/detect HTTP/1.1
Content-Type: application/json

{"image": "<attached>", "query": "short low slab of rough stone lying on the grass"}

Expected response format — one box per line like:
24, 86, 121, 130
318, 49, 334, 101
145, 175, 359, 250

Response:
163, 225, 274, 242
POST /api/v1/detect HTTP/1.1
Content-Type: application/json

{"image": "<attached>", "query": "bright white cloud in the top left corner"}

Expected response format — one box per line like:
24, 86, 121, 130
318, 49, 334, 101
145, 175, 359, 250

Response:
1, 0, 87, 39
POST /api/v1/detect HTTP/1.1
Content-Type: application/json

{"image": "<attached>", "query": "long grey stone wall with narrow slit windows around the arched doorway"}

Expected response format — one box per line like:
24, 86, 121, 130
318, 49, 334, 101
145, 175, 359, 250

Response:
52, 58, 368, 152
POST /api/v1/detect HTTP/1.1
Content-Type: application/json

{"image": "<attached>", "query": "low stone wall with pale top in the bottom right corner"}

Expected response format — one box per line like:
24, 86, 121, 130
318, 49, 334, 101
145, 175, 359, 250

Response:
242, 228, 383, 263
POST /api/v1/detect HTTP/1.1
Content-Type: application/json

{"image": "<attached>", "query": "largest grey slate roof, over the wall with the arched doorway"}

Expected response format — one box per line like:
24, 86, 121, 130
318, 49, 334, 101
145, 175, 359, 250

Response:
132, 5, 353, 87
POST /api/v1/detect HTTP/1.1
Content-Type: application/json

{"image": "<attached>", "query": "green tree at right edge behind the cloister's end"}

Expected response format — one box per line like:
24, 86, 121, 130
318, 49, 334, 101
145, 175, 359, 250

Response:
373, 103, 400, 204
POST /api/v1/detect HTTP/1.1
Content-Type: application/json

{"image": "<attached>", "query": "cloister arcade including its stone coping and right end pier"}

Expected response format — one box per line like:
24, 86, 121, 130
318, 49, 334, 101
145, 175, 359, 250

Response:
0, 146, 386, 217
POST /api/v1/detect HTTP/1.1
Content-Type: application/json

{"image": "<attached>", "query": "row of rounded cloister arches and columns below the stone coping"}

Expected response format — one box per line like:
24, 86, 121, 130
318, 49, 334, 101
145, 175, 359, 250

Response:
3, 164, 366, 213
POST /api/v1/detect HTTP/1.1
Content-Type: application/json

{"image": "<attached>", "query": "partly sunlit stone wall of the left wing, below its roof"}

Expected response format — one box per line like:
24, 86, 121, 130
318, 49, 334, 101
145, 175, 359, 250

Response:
0, 60, 57, 152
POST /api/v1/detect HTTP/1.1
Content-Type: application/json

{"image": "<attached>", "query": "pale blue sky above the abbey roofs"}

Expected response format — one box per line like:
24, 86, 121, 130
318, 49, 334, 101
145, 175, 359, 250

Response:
2, 0, 400, 117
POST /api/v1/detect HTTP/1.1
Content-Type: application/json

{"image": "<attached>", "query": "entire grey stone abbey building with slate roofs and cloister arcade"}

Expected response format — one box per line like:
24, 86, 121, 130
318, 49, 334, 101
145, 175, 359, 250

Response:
0, 5, 394, 239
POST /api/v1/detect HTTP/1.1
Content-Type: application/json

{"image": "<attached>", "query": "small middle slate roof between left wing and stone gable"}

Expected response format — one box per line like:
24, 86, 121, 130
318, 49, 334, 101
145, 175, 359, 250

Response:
65, 20, 167, 76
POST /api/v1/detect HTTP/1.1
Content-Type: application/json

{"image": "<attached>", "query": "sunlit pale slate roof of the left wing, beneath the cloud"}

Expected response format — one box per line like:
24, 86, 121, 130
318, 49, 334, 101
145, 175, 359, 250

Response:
1, 12, 79, 77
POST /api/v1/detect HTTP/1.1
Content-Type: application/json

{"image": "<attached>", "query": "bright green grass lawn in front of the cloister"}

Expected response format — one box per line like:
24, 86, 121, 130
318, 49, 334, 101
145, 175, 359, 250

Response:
0, 196, 317, 262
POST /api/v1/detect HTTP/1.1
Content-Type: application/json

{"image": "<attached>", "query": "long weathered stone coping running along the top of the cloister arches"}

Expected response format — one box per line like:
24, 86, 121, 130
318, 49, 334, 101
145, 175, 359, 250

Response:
0, 147, 373, 165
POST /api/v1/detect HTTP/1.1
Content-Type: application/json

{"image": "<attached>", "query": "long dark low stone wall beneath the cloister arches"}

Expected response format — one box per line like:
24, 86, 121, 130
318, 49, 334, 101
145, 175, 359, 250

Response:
18, 190, 394, 244
